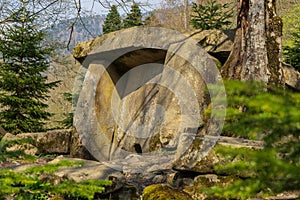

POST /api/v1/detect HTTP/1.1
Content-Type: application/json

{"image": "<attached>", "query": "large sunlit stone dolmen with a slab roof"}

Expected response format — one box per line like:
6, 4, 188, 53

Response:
73, 27, 223, 161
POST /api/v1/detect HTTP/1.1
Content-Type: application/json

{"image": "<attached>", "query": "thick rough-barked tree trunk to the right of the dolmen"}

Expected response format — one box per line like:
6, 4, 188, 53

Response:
222, 0, 284, 85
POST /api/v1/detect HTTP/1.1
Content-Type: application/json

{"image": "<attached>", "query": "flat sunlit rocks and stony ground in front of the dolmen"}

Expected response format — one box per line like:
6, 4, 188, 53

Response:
0, 155, 300, 200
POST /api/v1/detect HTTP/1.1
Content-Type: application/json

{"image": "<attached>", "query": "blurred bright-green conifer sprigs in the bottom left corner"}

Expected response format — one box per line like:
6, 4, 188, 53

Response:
0, 139, 112, 200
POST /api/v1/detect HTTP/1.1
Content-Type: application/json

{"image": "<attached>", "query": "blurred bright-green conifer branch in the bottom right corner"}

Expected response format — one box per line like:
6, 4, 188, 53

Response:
202, 147, 300, 199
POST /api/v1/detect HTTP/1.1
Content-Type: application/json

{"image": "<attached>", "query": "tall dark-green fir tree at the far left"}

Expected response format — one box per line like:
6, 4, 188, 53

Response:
0, 0, 58, 133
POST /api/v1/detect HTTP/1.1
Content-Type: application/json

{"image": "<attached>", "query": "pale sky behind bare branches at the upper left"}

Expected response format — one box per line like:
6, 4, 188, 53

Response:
0, 0, 147, 48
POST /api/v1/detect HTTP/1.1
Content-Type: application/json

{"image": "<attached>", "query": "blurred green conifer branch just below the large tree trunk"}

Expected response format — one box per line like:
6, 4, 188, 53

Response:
224, 81, 300, 163
